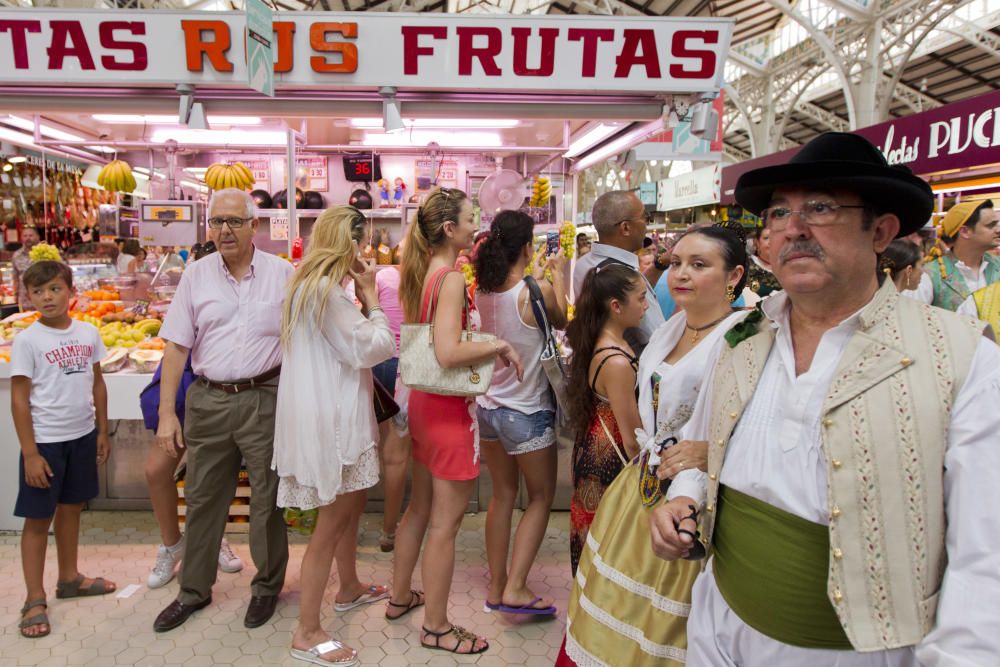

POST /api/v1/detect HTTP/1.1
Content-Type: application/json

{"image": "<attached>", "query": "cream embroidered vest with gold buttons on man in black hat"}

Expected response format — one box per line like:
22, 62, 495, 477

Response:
700, 281, 981, 651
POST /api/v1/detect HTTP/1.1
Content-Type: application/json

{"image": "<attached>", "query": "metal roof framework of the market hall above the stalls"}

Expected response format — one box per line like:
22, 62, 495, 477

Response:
0, 0, 1000, 160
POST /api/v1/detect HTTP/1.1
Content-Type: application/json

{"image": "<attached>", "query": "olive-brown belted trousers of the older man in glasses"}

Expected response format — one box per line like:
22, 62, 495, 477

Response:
177, 382, 288, 604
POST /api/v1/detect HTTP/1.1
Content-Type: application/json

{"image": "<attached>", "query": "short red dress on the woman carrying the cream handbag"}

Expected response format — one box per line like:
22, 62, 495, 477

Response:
407, 267, 479, 480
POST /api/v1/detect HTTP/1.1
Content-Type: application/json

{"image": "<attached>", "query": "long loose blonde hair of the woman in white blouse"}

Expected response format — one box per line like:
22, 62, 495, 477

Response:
281, 206, 360, 345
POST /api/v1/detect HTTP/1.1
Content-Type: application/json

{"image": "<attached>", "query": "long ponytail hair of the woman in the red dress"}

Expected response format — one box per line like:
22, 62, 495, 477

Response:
399, 188, 467, 322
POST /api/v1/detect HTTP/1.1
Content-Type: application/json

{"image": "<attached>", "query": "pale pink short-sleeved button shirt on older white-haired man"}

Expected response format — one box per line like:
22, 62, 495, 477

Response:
160, 248, 293, 382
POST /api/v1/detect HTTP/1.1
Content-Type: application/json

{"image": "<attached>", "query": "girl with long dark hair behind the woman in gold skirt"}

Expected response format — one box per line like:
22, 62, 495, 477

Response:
566, 263, 649, 575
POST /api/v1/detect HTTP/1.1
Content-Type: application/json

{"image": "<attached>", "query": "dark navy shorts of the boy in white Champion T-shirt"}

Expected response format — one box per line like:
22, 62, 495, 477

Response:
14, 431, 98, 519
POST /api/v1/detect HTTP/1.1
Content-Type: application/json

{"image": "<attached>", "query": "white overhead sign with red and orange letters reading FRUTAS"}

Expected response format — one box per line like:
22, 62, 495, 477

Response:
0, 9, 733, 94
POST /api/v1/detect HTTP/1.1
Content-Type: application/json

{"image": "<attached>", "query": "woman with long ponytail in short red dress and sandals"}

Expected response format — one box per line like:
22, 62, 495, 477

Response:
385, 188, 523, 654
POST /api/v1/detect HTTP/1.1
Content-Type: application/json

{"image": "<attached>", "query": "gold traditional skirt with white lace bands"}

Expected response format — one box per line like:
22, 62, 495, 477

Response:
566, 464, 700, 667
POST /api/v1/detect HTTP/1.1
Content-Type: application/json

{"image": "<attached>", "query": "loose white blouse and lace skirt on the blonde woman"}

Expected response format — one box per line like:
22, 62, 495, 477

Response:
271, 288, 396, 509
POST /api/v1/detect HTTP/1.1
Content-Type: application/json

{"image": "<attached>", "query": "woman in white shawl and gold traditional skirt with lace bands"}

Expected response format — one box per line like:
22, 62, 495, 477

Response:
557, 227, 747, 666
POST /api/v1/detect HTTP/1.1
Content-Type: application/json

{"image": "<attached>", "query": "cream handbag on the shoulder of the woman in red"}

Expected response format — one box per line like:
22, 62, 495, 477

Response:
399, 273, 496, 396
